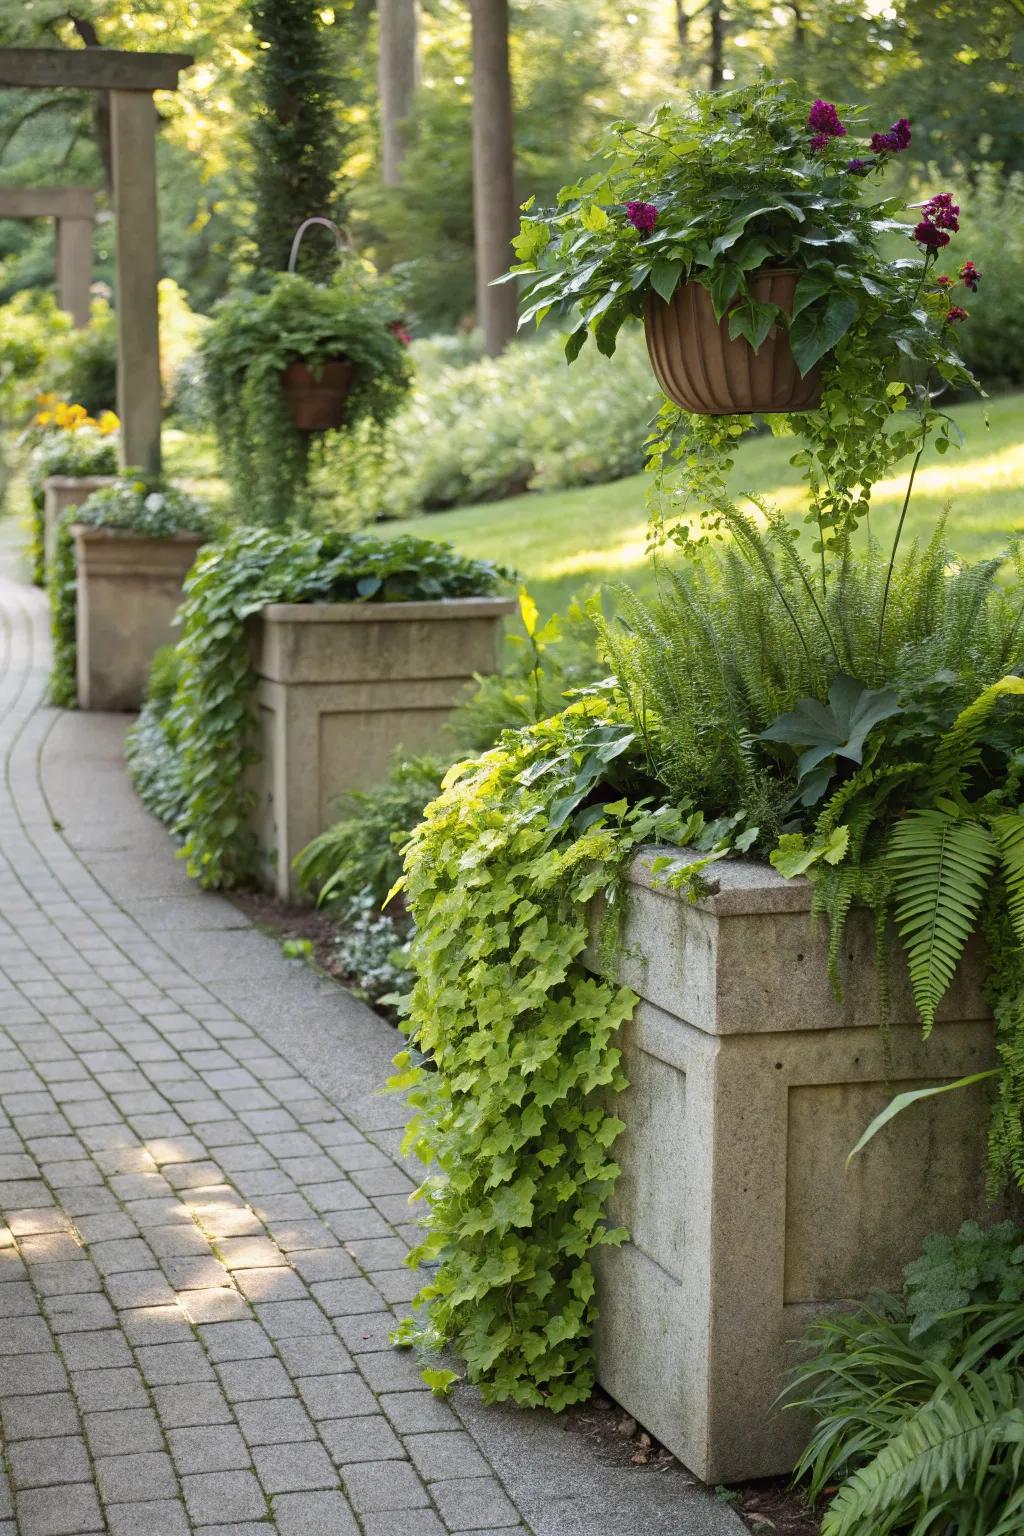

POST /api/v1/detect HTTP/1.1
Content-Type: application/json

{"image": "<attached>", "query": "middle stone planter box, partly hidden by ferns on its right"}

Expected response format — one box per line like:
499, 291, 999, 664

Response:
250, 598, 516, 900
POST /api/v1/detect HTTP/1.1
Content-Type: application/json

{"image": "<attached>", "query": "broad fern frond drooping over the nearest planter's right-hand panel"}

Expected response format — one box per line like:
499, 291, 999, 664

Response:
886, 811, 994, 1035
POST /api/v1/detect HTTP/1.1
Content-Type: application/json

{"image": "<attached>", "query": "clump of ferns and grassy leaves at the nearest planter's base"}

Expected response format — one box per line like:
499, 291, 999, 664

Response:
789, 1223, 1024, 1536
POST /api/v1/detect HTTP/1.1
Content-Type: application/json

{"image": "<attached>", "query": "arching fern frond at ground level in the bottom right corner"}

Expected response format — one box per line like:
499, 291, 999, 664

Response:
821, 1362, 1024, 1536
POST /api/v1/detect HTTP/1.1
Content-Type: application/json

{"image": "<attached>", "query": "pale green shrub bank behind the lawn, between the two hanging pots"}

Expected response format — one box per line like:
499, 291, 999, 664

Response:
363, 330, 662, 518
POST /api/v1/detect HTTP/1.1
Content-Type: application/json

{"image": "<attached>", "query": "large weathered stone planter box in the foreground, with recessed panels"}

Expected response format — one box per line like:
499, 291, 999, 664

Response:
596, 852, 1021, 1484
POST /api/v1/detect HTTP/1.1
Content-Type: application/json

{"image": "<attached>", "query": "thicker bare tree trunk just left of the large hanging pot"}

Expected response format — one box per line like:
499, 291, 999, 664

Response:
470, 0, 519, 358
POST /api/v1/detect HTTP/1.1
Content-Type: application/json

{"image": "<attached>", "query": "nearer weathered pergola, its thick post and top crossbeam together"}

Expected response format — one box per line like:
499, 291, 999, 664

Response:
0, 48, 192, 475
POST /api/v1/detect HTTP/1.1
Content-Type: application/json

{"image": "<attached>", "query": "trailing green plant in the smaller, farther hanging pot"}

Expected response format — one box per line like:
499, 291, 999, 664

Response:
201, 264, 408, 524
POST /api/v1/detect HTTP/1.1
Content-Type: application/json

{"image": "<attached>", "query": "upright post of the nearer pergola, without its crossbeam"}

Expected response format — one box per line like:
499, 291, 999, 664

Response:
111, 91, 161, 475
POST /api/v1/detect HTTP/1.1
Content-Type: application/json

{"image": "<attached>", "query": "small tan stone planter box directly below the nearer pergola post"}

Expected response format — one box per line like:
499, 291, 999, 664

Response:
71, 524, 203, 710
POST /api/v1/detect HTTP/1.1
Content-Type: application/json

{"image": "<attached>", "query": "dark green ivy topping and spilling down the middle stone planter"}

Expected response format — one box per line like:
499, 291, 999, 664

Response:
129, 528, 505, 889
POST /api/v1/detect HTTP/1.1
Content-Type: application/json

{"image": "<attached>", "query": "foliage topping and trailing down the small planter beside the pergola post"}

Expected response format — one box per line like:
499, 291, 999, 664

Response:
49, 470, 213, 708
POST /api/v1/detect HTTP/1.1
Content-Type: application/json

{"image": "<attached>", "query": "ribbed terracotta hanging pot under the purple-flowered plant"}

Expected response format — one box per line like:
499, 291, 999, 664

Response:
645, 267, 821, 416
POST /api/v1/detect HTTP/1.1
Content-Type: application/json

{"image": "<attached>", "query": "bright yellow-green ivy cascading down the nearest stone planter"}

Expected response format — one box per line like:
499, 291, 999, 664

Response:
391, 703, 685, 1410
